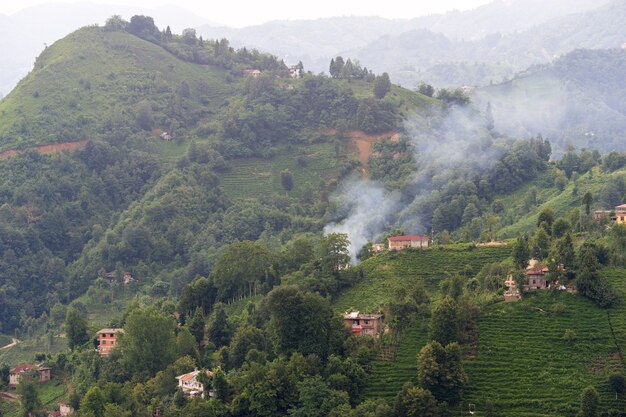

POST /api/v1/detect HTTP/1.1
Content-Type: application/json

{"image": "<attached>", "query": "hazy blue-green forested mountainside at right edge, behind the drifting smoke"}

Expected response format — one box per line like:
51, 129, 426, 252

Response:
475, 49, 626, 152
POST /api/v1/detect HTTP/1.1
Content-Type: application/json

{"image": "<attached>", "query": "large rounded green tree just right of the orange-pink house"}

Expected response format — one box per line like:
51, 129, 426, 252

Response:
120, 307, 176, 378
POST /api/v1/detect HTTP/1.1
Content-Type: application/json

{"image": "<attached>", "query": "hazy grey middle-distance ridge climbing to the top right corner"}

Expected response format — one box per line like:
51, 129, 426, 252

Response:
346, 0, 626, 86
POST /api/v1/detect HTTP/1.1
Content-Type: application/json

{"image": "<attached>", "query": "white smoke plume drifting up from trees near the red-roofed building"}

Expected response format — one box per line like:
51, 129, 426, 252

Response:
324, 103, 506, 260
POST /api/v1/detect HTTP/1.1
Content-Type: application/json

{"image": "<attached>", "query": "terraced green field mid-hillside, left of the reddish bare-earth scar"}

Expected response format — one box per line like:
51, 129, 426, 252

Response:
220, 143, 339, 199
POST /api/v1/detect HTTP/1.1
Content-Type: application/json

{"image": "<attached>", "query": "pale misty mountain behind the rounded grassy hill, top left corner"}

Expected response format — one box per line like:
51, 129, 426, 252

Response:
0, 2, 208, 95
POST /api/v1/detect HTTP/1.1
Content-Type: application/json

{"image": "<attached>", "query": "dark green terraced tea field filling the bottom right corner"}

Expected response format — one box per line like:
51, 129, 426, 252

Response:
458, 292, 626, 417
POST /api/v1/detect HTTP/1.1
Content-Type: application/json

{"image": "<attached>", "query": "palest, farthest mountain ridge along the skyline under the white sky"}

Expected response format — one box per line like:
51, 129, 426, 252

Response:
198, 0, 608, 75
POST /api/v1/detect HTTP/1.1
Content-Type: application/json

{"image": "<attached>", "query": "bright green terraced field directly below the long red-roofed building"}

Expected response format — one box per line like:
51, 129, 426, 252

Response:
334, 245, 511, 312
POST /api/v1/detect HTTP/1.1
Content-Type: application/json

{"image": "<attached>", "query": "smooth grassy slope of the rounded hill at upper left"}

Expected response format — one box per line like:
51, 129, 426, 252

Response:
0, 27, 231, 150
